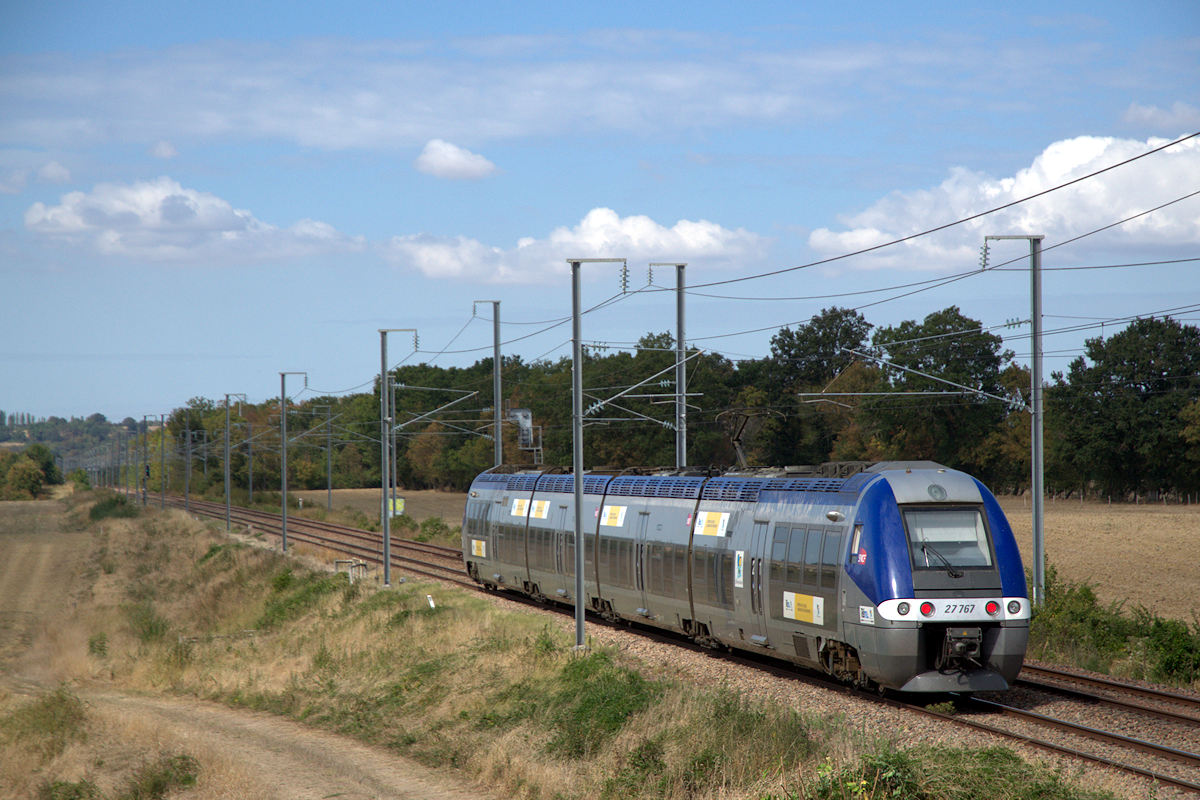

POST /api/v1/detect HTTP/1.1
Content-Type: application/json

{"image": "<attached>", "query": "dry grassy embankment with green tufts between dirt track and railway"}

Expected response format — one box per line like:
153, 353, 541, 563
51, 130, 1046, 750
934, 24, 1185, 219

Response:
0, 491, 1142, 799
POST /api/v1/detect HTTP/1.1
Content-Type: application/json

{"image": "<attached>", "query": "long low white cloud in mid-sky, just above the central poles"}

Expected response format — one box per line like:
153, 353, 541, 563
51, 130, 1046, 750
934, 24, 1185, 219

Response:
384, 209, 768, 283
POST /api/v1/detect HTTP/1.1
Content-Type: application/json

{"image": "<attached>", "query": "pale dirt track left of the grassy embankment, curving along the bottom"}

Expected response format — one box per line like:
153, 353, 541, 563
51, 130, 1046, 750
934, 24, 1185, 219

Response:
0, 501, 487, 800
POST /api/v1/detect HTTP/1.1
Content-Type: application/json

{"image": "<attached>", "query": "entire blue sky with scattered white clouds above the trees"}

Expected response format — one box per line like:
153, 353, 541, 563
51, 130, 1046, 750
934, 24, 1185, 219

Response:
0, 0, 1200, 420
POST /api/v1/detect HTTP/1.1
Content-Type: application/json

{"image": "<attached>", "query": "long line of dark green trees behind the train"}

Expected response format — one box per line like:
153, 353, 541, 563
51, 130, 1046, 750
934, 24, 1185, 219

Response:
51, 306, 1200, 500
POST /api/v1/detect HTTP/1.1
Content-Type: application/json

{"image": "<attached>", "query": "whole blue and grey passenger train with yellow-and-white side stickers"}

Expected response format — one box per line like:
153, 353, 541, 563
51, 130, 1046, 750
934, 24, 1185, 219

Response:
462, 462, 1031, 693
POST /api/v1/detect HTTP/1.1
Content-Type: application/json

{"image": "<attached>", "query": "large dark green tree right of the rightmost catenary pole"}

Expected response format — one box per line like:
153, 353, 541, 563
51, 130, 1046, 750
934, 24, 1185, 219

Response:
1046, 318, 1200, 495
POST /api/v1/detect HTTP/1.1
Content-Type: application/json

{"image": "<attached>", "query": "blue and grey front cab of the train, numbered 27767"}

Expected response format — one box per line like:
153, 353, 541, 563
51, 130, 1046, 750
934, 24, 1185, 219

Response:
842, 468, 1030, 692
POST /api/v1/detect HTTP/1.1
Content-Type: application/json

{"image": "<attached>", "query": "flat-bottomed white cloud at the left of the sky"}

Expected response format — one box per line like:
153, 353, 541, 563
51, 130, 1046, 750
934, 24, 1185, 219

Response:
25, 178, 364, 264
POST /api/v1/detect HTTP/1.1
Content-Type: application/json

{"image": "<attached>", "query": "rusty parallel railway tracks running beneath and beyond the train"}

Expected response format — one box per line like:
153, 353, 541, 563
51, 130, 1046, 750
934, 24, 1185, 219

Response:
142, 497, 1200, 794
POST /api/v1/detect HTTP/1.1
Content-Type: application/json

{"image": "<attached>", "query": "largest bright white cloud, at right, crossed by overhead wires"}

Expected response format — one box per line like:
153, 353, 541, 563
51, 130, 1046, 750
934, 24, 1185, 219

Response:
809, 137, 1200, 271
